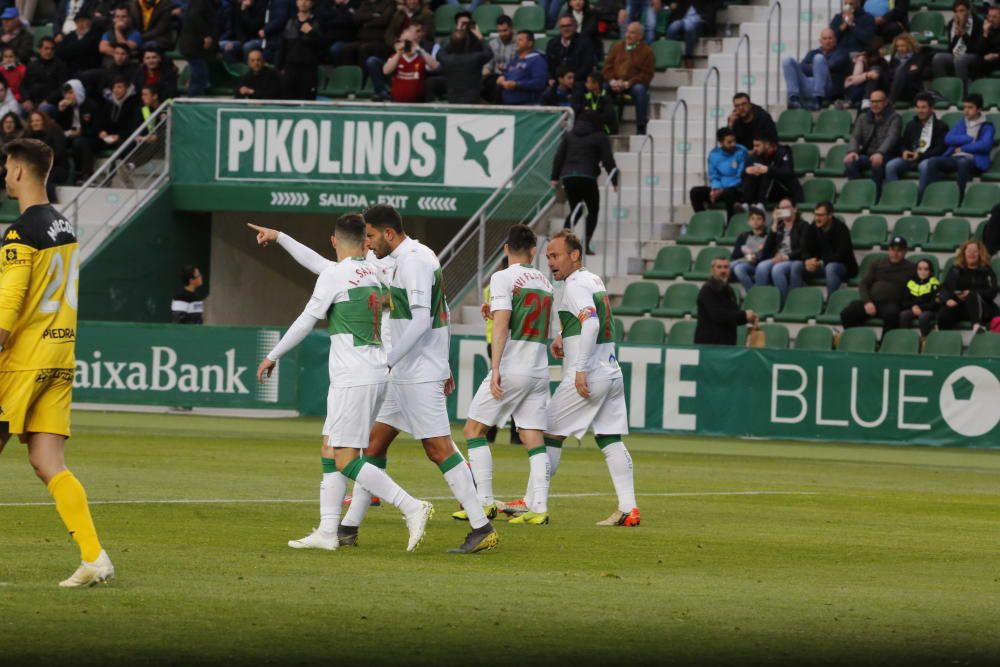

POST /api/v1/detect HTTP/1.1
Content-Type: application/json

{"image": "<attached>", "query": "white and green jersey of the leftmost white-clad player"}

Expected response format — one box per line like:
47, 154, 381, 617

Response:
305, 257, 389, 387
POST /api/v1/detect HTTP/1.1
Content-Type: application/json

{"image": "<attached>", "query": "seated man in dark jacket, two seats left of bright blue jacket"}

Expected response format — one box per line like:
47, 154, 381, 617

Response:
844, 90, 901, 191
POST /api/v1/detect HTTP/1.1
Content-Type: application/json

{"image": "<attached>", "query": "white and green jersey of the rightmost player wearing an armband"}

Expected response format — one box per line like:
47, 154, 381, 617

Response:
559, 268, 622, 380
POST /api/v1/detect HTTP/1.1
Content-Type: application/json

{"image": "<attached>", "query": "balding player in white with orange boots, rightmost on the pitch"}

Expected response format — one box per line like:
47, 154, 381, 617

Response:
544, 231, 639, 526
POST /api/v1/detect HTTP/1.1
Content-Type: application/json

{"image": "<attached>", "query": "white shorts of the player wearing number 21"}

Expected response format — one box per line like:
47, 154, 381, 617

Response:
469, 371, 549, 431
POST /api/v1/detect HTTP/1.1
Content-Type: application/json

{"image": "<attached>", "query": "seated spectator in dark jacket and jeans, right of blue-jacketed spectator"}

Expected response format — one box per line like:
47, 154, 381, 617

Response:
754, 197, 812, 303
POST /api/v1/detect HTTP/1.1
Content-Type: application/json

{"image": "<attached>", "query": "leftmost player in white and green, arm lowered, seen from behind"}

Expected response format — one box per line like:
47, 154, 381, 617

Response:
257, 214, 434, 551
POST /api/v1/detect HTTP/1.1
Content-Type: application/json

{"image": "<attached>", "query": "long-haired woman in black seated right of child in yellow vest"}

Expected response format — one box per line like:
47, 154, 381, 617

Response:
938, 239, 1000, 330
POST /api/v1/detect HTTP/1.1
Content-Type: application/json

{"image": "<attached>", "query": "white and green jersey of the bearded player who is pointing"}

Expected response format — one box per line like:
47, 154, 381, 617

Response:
389, 237, 451, 384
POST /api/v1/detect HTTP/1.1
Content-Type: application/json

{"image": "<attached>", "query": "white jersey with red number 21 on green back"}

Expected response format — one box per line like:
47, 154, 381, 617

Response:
490, 264, 552, 379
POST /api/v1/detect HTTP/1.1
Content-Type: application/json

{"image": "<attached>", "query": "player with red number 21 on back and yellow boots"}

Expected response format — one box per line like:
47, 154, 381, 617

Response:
452, 225, 552, 525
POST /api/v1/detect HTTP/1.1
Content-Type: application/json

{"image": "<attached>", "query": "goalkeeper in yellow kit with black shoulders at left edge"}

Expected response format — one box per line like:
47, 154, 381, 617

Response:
0, 139, 115, 588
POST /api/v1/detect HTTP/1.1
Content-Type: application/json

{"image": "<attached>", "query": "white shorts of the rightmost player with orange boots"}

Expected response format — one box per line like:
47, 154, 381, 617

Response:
546, 373, 628, 438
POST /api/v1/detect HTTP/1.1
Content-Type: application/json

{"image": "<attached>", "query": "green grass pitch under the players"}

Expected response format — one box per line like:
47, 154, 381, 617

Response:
0, 413, 1000, 666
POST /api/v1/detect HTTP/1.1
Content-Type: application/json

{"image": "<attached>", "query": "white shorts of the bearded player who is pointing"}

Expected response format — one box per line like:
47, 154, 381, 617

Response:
375, 380, 451, 440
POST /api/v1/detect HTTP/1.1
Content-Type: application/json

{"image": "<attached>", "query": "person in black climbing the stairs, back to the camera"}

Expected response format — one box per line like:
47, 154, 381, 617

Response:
552, 111, 618, 255
